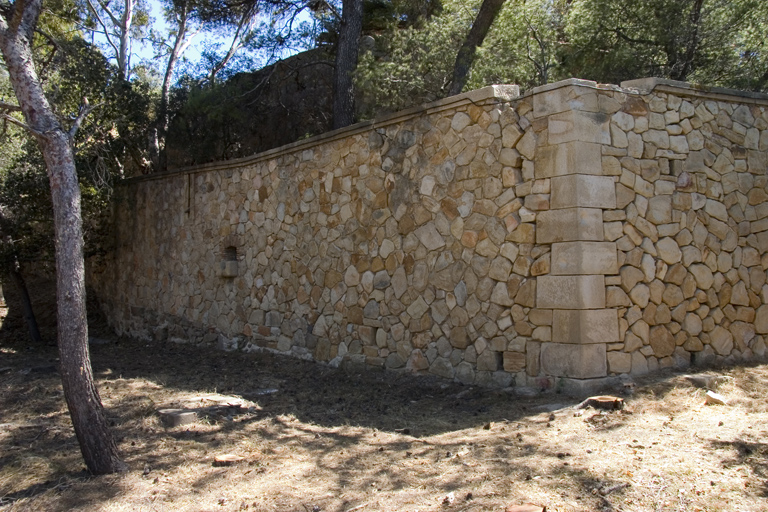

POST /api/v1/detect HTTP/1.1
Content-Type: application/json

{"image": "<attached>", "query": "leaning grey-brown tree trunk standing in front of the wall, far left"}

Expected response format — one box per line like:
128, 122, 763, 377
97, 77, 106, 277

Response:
0, 0, 126, 474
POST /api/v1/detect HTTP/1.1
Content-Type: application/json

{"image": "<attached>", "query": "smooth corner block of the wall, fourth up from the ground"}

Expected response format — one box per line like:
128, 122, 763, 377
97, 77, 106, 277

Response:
550, 242, 619, 275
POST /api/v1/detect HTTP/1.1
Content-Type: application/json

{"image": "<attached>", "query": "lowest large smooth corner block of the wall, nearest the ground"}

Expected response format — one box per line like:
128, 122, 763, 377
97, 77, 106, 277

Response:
541, 343, 608, 379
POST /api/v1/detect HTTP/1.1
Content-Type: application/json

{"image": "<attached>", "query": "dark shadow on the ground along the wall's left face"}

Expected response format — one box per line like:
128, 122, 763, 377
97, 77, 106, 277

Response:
91, 338, 577, 436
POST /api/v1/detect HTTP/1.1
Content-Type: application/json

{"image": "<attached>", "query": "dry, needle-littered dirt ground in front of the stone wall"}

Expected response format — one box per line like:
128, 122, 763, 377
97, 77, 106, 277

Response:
0, 282, 768, 512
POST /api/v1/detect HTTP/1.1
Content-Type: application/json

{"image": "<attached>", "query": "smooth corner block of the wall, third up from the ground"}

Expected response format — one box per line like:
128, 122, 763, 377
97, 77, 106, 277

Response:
536, 276, 605, 309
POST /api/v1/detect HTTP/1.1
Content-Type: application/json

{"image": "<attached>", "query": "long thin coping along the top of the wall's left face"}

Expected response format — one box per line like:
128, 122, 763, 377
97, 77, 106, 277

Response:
126, 85, 520, 184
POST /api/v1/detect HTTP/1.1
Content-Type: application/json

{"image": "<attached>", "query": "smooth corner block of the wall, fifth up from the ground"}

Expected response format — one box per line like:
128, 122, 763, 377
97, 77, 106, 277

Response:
536, 208, 605, 244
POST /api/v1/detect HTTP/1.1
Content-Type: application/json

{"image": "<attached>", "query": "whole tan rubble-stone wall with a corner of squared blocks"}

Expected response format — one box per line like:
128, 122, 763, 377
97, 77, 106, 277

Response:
90, 79, 768, 391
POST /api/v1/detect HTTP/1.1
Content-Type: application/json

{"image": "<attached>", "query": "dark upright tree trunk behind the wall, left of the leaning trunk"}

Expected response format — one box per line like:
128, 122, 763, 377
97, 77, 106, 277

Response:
333, 0, 363, 129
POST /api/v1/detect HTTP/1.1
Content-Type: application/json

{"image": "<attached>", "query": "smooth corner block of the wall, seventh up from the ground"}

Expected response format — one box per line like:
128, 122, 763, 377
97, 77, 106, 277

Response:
533, 141, 603, 179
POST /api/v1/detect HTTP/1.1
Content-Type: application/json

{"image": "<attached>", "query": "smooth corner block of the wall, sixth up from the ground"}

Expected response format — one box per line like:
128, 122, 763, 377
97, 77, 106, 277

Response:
550, 174, 616, 210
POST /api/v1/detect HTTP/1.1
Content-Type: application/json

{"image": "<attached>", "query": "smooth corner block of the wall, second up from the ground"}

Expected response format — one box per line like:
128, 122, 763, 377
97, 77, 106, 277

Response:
552, 309, 619, 345
